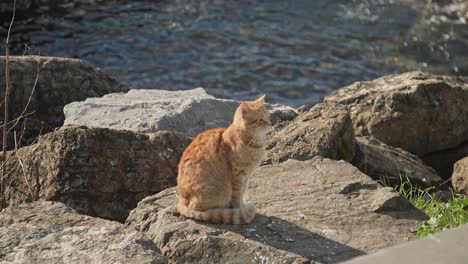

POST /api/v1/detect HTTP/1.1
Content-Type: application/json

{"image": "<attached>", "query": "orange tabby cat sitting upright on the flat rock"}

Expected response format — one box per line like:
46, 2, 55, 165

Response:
177, 96, 270, 224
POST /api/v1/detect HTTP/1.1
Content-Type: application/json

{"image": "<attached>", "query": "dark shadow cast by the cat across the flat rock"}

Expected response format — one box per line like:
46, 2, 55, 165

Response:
199, 214, 366, 263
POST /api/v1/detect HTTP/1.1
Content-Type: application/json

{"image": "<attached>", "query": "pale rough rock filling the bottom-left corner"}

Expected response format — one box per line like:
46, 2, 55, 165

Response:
0, 201, 166, 264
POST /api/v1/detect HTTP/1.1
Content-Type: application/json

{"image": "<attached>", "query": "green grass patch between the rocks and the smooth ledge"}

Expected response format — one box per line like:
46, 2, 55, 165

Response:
379, 176, 468, 237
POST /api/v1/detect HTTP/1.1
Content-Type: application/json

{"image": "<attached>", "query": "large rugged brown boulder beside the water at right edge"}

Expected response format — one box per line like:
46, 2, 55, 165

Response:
325, 72, 468, 156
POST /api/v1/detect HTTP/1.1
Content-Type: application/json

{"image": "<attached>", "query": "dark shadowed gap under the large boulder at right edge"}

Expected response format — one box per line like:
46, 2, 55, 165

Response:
421, 142, 468, 179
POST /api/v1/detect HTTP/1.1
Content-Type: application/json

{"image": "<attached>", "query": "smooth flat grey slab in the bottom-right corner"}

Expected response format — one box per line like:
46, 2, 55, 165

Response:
343, 225, 468, 264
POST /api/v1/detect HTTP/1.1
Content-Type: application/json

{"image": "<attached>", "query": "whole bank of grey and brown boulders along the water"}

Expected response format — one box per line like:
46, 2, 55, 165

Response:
0, 56, 468, 263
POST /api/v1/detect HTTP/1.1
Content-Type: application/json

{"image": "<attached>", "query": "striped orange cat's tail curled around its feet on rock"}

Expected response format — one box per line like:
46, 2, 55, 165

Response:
177, 203, 255, 225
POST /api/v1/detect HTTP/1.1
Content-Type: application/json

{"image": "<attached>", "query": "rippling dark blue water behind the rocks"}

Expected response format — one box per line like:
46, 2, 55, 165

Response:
0, 0, 468, 106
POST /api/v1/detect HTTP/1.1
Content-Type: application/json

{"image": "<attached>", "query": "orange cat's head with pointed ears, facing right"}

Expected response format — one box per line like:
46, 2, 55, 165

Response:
234, 96, 271, 131
